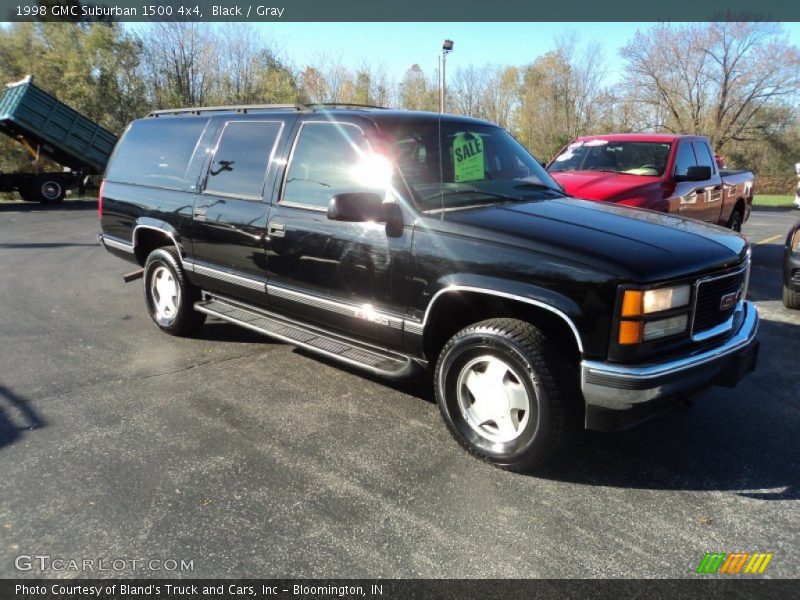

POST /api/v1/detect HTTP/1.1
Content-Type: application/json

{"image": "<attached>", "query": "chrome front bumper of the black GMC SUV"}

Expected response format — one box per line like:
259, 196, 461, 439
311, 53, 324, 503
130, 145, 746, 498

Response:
581, 302, 758, 429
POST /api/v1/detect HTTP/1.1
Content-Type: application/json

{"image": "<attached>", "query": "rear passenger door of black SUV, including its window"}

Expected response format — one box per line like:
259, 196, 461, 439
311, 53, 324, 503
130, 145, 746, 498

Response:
190, 114, 295, 304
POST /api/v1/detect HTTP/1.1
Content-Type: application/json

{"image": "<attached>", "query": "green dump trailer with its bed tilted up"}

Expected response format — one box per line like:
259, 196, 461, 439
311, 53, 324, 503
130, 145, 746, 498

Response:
0, 76, 117, 203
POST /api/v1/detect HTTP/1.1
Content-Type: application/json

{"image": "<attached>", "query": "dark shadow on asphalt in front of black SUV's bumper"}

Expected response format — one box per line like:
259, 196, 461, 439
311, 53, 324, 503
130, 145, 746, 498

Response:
533, 319, 800, 500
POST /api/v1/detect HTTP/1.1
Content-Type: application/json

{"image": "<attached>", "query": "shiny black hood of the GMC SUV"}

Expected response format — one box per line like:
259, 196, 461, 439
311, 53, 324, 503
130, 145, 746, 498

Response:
445, 198, 747, 283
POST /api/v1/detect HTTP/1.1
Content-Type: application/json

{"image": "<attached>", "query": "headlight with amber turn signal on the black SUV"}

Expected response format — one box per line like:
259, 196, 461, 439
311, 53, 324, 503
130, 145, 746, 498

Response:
617, 284, 692, 346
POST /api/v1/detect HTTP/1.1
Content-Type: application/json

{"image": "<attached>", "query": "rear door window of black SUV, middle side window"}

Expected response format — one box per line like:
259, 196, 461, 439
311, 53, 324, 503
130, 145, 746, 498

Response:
205, 121, 283, 199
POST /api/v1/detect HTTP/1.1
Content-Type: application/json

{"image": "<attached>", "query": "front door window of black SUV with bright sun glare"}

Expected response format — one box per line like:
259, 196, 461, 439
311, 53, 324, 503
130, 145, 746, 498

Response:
281, 122, 367, 208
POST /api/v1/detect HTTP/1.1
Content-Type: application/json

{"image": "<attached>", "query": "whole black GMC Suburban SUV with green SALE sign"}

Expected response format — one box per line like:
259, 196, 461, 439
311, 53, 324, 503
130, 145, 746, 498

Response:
99, 105, 758, 471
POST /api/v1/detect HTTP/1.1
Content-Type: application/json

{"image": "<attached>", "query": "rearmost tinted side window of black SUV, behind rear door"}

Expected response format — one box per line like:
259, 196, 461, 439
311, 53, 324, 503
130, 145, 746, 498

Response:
106, 118, 208, 190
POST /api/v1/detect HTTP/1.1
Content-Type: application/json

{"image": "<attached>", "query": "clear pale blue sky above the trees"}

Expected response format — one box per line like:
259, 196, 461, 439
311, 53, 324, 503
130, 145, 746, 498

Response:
127, 22, 800, 83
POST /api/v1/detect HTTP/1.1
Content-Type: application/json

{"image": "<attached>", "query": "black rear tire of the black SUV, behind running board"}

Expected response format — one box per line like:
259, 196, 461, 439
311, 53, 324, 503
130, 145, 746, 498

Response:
144, 247, 206, 336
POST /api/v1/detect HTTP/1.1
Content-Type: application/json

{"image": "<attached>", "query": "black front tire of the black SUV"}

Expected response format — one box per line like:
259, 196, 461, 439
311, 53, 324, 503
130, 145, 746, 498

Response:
434, 319, 581, 472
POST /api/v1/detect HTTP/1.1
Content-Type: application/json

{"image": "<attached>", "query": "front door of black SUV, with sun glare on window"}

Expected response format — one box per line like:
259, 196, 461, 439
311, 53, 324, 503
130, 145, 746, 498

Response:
267, 117, 411, 349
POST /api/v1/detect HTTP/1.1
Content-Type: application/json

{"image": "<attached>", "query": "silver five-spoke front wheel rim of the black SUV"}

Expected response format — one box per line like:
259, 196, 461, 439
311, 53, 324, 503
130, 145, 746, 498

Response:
456, 355, 531, 443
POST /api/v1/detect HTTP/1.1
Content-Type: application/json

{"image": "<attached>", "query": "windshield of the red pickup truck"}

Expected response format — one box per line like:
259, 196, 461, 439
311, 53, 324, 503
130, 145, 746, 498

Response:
548, 140, 671, 177
